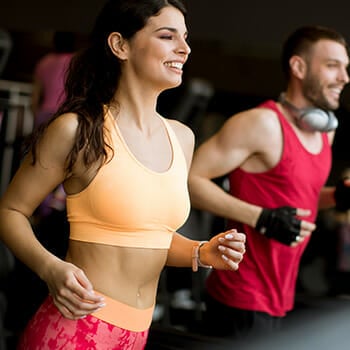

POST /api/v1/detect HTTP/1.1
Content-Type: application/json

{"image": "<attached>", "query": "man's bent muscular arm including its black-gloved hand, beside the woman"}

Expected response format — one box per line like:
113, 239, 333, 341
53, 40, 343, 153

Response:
189, 108, 315, 245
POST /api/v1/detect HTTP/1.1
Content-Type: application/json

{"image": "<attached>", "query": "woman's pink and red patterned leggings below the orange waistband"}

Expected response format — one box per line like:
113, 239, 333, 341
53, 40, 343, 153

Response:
17, 297, 148, 350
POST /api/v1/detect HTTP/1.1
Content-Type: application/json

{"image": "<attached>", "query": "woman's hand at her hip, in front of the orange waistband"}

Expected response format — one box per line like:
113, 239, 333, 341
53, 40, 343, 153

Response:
43, 259, 105, 320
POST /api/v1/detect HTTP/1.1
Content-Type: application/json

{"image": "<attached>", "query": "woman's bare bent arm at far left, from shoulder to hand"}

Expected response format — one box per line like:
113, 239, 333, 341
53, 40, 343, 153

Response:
0, 114, 104, 318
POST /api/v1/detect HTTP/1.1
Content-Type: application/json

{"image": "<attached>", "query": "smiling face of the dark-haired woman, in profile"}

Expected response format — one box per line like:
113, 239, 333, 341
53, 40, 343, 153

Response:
123, 6, 191, 90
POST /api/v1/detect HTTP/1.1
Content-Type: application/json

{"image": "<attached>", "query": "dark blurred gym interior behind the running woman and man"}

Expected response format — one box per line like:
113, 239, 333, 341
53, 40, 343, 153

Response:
0, 0, 350, 350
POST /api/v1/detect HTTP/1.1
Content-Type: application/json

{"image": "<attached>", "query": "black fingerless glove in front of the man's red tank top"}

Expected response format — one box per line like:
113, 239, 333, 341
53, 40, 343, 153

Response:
255, 207, 301, 245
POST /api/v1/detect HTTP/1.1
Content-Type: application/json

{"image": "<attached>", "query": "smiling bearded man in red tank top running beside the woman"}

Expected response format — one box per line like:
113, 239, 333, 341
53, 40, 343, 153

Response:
189, 26, 350, 336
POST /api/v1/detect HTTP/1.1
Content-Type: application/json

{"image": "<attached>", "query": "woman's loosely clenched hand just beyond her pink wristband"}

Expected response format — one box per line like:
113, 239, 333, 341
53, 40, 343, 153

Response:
199, 230, 246, 271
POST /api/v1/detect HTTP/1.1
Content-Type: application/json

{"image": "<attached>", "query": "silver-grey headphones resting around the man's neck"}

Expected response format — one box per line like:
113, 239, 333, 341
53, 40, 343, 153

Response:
278, 93, 338, 132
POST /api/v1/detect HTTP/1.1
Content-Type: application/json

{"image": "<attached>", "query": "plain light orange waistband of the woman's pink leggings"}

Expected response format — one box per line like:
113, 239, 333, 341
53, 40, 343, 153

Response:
91, 292, 154, 332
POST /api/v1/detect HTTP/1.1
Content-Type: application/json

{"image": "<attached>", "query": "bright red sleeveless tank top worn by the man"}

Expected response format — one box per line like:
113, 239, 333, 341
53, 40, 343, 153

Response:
206, 101, 331, 316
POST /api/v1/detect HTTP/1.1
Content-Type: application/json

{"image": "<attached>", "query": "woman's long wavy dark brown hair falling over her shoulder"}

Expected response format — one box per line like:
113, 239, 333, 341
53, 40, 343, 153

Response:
30, 0, 186, 173
